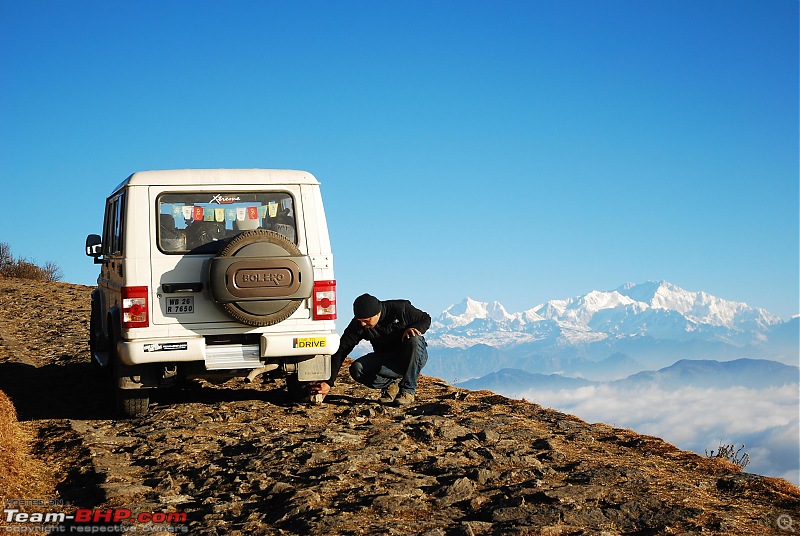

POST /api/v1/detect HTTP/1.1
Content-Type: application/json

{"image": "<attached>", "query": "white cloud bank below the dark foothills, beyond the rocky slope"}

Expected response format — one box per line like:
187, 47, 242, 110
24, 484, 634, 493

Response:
519, 384, 800, 485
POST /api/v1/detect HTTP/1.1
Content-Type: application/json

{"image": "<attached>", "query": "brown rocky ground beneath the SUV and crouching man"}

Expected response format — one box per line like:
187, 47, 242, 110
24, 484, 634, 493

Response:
0, 279, 800, 535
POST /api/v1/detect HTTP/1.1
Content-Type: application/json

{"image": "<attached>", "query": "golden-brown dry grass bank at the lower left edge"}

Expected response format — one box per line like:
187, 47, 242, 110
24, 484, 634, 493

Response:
0, 391, 53, 501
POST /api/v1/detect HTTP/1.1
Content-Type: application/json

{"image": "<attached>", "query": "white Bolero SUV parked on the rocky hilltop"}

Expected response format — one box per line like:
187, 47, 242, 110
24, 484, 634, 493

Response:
86, 169, 339, 416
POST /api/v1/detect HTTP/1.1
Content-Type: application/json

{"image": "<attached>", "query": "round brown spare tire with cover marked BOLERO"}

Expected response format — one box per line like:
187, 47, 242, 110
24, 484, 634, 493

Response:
209, 229, 314, 326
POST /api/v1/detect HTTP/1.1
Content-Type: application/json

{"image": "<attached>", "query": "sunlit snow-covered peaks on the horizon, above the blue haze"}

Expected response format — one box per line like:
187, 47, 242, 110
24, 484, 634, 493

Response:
429, 281, 782, 348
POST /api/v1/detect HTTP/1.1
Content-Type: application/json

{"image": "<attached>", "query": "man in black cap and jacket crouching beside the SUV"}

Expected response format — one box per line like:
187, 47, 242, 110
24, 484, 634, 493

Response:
310, 294, 431, 406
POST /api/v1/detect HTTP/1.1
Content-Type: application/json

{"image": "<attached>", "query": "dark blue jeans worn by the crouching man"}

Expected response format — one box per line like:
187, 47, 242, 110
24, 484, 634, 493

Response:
350, 335, 428, 394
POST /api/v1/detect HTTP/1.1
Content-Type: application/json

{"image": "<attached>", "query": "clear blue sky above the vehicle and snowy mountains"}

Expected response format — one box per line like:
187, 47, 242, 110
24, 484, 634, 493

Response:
0, 0, 800, 319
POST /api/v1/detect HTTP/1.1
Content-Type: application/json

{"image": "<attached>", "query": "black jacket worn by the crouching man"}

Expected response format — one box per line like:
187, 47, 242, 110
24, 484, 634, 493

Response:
327, 300, 431, 387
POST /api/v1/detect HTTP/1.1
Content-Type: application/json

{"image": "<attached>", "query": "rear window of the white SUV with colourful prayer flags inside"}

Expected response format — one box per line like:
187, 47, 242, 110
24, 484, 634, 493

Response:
156, 192, 297, 253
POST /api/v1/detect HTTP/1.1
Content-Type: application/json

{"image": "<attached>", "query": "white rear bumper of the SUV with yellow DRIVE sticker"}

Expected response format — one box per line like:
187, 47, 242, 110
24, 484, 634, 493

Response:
117, 332, 339, 370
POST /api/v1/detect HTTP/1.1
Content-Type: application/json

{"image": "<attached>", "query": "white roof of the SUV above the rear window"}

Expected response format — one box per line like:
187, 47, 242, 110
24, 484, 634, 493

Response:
114, 169, 319, 192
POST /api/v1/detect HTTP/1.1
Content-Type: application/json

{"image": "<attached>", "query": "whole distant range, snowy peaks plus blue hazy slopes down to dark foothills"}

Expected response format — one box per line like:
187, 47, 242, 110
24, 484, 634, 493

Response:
426, 281, 800, 381
